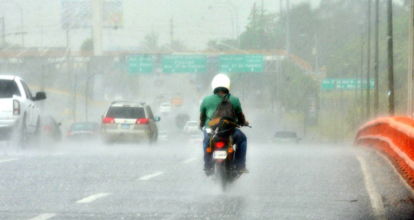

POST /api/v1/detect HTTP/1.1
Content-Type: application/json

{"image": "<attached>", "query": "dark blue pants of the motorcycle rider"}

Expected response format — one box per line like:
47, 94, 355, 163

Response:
203, 129, 247, 169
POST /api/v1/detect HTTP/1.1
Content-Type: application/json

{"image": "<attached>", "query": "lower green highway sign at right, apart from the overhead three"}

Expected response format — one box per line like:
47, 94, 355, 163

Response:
321, 79, 375, 90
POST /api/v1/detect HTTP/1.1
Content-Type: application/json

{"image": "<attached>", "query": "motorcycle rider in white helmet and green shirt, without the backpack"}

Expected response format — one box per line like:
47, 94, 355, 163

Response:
200, 74, 249, 175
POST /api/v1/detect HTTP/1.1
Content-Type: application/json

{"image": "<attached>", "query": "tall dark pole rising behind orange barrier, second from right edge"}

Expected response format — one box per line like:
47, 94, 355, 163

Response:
387, 0, 394, 116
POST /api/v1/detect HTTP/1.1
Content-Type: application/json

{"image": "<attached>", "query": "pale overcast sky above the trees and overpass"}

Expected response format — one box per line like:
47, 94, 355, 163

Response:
0, 0, 320, 50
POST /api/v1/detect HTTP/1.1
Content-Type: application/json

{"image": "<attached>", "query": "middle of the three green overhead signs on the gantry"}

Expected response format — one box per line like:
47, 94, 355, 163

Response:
162, 55, 207, 73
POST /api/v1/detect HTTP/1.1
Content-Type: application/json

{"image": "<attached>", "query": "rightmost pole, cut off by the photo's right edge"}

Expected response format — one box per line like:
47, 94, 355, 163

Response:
407, 0, 414, 118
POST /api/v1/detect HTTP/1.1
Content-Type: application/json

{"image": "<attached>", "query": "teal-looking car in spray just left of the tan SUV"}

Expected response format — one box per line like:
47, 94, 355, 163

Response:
67, 122, 100, 140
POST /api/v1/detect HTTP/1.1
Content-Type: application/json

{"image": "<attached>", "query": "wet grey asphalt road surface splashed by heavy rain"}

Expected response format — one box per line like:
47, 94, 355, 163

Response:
0, 139, 414, 220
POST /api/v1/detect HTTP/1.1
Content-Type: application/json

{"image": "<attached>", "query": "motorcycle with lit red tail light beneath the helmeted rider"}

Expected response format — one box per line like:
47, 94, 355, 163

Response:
207, 126, 250, 192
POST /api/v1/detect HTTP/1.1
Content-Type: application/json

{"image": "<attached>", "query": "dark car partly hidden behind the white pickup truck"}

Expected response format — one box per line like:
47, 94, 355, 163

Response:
40, 114, 62, 142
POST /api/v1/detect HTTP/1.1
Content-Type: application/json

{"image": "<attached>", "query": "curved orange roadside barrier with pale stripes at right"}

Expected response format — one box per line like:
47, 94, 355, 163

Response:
354, 117, 414, 189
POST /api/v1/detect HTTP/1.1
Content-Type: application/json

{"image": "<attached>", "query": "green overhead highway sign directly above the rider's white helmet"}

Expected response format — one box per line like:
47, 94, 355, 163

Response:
219, 54, 264, 73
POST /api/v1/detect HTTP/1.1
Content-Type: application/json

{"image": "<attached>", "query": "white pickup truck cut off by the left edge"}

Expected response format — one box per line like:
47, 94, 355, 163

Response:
0, 75, 46, 147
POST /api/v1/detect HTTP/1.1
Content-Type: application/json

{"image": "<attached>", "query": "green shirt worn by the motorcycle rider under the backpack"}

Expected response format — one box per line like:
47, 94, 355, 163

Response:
200, 95, 243, 128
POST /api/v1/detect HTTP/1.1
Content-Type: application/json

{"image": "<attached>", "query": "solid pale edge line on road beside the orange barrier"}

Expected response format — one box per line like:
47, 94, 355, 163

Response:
357, 156, 386, 220
